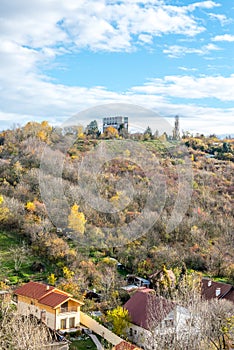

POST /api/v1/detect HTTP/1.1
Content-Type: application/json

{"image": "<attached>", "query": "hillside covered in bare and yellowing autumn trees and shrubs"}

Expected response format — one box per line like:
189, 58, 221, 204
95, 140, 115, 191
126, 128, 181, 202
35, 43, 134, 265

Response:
0, 122, 234, 302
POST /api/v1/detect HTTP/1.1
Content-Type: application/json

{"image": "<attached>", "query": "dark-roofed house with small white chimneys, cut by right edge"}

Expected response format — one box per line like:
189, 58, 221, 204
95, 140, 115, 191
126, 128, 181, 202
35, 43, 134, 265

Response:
201, 278, 234, 303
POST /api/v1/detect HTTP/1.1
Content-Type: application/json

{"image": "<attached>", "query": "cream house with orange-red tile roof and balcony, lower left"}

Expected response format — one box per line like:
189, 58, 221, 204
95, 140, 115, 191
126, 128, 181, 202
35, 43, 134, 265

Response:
14, 282, 83, 330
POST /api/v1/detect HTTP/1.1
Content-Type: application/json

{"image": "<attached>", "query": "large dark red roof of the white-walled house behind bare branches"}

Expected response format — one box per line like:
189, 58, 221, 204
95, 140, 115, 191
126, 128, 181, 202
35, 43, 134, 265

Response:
124, 291, 176, 329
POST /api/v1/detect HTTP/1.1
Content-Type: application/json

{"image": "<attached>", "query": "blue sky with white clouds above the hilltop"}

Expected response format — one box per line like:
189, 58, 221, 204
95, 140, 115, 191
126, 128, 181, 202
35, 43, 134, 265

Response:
0, 0, 234, 135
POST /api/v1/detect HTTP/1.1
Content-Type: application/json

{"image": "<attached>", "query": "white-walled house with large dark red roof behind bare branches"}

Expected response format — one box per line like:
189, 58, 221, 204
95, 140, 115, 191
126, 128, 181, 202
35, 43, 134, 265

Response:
124, 289, 191, 350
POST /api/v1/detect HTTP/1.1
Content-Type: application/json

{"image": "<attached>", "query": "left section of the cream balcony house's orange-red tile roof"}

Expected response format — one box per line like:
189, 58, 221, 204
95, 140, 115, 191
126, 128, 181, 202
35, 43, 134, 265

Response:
15, 282, 55, 300
